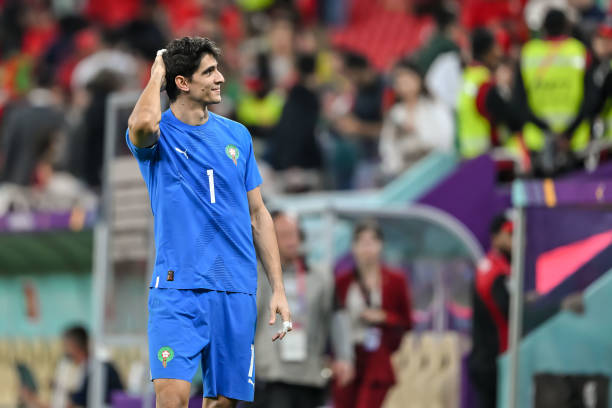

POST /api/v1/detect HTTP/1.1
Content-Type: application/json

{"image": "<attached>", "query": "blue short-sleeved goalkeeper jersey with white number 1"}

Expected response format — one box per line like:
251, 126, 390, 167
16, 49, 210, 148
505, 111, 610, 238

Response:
126, 109, 261, 294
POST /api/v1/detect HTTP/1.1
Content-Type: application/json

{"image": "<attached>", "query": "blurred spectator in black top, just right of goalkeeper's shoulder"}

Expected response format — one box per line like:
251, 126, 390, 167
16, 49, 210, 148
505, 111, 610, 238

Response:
265, 55, 322, 192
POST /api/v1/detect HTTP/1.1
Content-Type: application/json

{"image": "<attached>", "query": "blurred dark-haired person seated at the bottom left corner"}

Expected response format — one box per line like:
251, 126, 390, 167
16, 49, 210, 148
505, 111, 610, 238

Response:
20, 326, 123, 408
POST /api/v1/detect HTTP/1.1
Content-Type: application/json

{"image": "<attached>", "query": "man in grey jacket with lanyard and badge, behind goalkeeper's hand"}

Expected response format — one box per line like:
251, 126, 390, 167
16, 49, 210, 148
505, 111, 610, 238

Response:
254, 212, 354, 408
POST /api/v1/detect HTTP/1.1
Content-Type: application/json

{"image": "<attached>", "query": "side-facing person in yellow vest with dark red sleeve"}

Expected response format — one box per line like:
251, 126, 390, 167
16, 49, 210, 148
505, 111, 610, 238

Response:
457, 28, 522, 159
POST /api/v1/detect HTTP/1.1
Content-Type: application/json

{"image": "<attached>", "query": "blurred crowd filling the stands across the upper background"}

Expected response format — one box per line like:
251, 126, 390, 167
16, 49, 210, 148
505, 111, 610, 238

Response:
0, 0, 612, 214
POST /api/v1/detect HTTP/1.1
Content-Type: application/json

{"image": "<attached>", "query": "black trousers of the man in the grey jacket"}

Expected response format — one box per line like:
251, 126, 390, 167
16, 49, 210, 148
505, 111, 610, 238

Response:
251, 382, 325, 408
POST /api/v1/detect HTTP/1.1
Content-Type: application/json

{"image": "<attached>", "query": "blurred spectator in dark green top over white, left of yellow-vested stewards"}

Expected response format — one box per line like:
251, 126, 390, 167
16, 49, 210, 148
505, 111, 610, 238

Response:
417, 7, 461, 108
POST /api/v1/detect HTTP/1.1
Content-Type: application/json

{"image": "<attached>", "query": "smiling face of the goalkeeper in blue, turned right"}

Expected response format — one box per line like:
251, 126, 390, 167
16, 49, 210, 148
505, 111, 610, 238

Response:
189, 54, 225, 105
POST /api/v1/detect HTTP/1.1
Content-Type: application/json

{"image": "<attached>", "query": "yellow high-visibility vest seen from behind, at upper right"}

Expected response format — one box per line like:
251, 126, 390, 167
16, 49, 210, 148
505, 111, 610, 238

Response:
521, 38, 590, 151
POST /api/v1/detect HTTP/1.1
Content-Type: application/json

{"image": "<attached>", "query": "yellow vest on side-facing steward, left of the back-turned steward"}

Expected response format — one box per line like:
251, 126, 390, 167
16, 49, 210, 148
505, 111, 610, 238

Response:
457, 65, 491, 158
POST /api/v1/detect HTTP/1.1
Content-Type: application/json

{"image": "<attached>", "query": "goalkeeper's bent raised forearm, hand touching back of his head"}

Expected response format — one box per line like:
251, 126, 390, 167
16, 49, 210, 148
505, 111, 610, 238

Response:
128, 53, 166, 147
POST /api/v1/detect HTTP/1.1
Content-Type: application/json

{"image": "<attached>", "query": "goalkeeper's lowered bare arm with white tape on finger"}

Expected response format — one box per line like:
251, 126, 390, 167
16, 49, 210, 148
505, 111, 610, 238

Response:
247, 187, 291, 341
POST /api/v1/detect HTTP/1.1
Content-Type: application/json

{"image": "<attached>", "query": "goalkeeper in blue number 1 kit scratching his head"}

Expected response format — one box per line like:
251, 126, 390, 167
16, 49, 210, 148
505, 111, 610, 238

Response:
126, 37, 291, 408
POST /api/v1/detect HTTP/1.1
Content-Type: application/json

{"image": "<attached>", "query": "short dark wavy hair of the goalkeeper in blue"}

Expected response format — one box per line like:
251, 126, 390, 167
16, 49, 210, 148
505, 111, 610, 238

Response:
163, 37, 221, 102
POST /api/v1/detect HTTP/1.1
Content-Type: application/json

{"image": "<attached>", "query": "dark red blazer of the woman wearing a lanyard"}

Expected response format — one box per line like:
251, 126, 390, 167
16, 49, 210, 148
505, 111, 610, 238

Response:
336, 266, 412, 384
